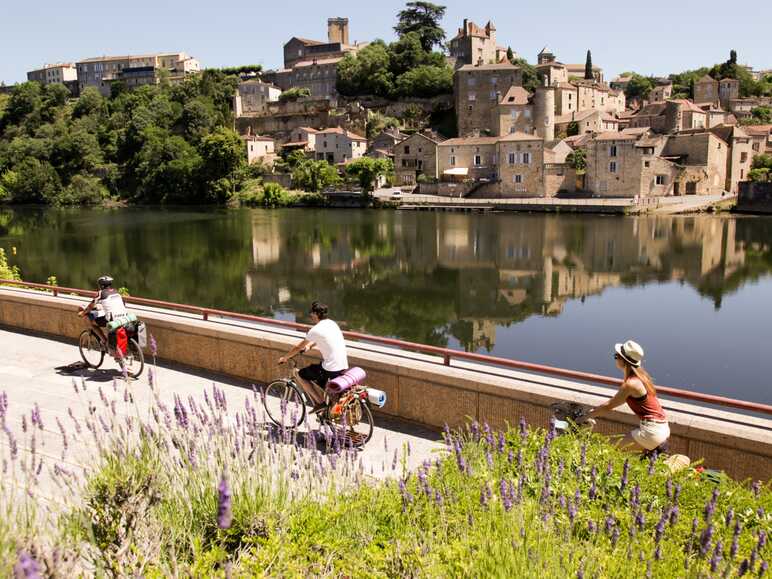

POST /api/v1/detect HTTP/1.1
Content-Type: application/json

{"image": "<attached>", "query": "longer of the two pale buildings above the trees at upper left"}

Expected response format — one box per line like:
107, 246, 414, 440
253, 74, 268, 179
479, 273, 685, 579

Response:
75, 52, 201, 96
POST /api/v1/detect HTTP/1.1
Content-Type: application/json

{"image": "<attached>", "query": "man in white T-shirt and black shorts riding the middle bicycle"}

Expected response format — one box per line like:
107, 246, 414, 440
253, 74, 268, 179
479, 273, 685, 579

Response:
279, 302, 348, 412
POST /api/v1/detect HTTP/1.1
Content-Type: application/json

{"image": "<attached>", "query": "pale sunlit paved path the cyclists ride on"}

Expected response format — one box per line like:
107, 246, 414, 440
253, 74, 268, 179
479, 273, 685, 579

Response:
0, 329, 441, 496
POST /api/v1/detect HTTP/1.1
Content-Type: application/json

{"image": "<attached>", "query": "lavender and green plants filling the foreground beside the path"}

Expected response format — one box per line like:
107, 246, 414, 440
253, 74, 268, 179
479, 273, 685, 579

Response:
0, 384, 772, 578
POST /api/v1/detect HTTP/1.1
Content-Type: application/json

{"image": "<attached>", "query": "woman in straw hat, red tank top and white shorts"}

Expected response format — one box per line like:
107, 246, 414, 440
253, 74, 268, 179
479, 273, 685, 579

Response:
585, 340, 670, 452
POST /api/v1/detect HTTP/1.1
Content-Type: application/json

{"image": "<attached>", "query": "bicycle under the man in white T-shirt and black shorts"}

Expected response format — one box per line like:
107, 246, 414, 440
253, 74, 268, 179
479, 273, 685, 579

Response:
262, 358, 374, 446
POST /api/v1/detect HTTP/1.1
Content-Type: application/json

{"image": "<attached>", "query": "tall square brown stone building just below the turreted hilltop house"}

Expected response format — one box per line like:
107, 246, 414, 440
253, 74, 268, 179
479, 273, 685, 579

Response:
453, 61, 523, 136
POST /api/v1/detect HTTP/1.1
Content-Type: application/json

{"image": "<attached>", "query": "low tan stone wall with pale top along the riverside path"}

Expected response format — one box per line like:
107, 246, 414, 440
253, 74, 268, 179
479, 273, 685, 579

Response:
0, 288, 772, 480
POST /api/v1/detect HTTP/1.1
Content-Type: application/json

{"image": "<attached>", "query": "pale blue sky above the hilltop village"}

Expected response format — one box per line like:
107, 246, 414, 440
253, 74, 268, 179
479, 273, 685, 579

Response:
0, 0, 772, 83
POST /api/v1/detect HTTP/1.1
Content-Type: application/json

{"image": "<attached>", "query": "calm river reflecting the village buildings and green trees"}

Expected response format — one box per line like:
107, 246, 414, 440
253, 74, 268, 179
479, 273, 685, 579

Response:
0, 208, 772, 403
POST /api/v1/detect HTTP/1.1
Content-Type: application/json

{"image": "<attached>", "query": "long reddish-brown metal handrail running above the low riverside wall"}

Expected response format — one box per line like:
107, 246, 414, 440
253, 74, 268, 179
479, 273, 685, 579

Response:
0, 279, 772, 415
